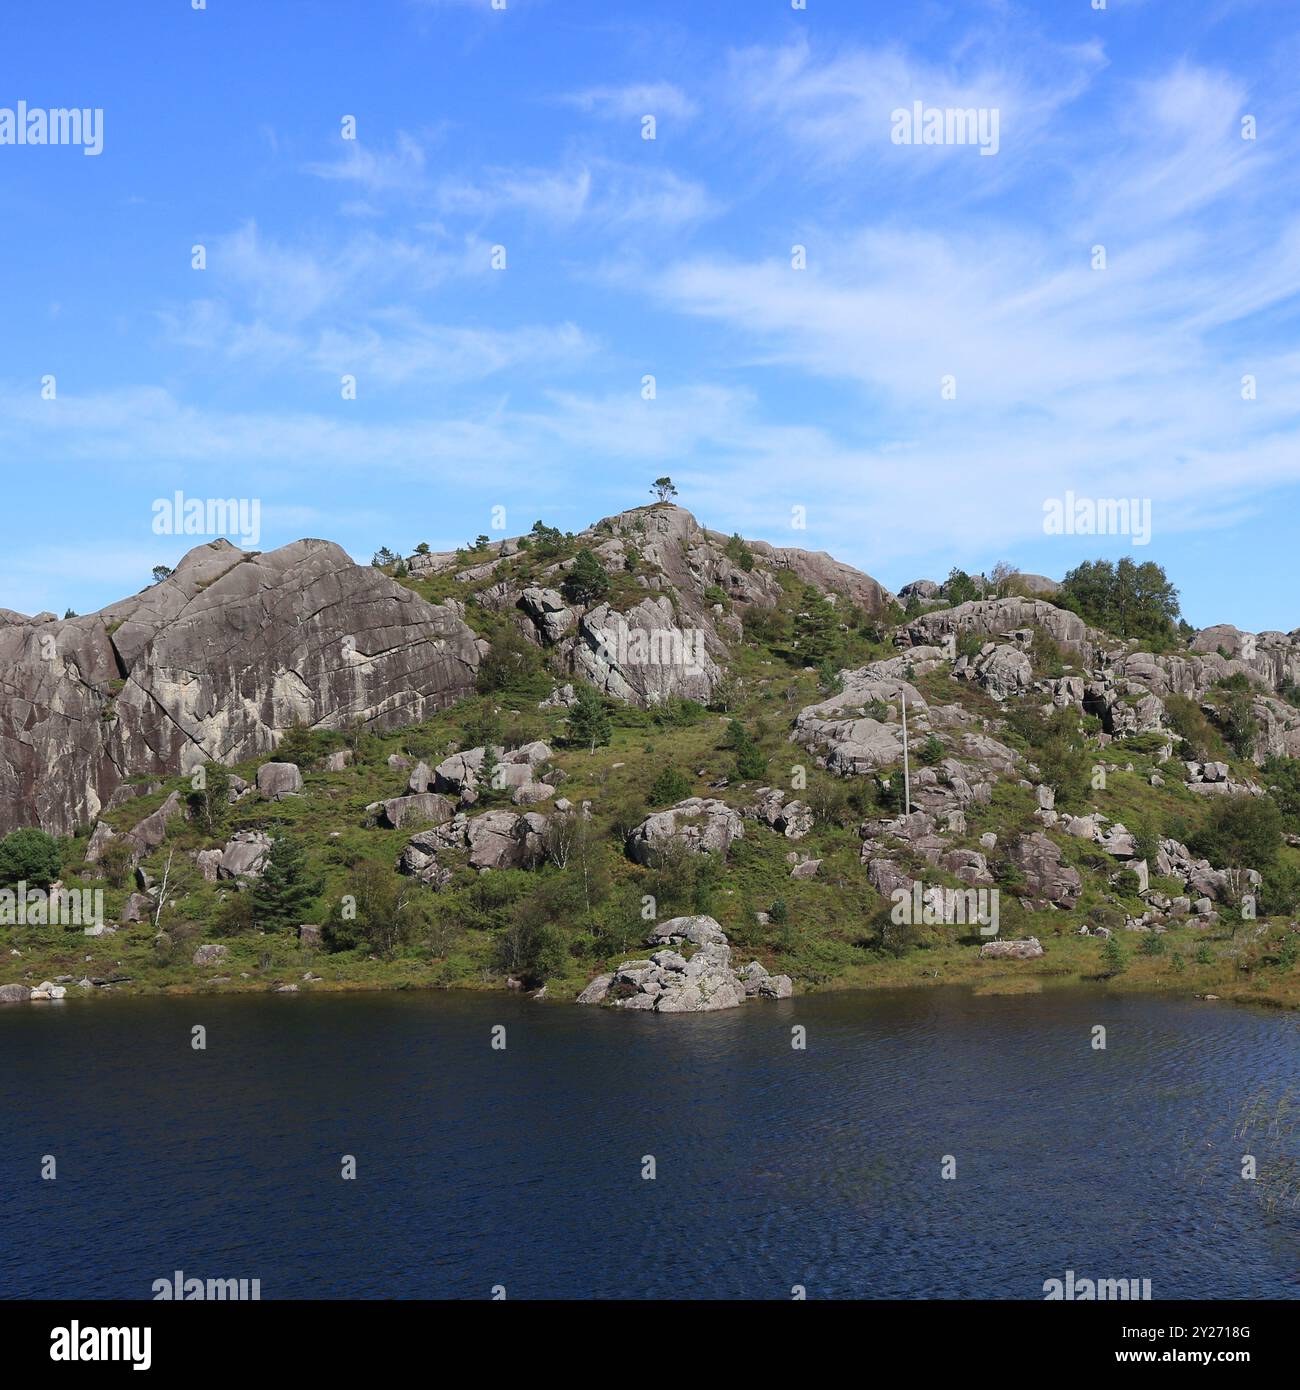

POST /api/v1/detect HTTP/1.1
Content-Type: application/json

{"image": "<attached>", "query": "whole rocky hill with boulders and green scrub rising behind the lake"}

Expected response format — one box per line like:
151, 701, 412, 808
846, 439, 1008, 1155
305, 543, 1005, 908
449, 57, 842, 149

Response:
0, 505, 1300, 1012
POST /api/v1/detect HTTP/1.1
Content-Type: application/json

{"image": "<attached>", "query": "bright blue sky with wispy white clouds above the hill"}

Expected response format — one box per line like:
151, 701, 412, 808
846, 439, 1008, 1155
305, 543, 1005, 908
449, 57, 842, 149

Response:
0, 0, 1300, 630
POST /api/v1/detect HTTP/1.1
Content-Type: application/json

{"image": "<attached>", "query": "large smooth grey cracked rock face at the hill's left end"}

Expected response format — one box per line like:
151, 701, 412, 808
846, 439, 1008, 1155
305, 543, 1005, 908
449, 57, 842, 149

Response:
0, 541, 480, 834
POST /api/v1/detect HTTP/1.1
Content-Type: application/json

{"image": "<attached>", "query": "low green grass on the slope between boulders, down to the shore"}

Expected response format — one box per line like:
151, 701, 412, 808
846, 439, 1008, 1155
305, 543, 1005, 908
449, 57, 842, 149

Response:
0, 558, 1300, 1008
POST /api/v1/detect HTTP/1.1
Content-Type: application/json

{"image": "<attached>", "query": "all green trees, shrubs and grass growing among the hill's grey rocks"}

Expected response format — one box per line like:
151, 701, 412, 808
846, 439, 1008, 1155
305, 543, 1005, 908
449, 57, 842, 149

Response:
10, 511, 1300, 1023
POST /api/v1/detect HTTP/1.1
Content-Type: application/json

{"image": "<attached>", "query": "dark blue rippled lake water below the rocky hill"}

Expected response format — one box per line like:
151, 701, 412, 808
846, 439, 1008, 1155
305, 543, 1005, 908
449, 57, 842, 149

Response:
0, 990, 1300, 1298
